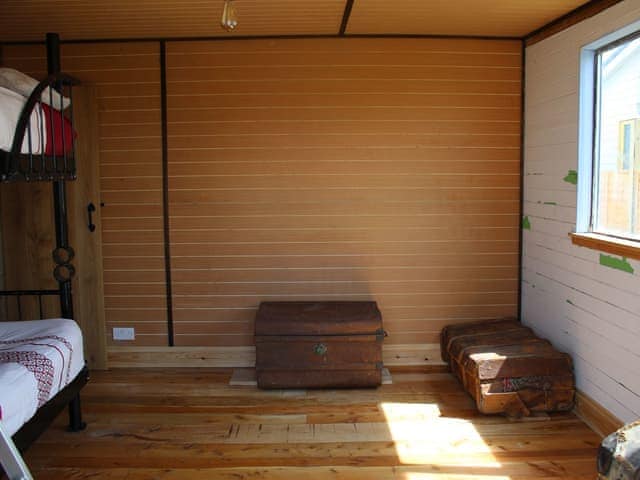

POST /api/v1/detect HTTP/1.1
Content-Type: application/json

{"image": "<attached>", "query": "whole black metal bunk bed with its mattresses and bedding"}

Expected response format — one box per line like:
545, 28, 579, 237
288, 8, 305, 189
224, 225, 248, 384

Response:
0, 34, 88, 478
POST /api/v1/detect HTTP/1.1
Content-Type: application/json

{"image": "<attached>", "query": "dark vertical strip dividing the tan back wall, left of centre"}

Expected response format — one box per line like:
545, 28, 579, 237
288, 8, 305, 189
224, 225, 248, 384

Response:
160, 40, 174, 347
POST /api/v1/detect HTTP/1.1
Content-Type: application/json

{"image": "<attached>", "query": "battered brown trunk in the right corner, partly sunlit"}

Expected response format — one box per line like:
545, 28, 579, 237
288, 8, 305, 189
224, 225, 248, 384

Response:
441, 320, 575, 416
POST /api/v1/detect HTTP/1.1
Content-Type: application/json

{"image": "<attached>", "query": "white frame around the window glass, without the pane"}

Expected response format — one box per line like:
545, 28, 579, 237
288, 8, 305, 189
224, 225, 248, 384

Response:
576, 21, 640, 238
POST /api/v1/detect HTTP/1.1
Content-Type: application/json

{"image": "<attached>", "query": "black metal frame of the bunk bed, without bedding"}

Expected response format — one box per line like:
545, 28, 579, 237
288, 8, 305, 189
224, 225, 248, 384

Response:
0, 33, 89, 451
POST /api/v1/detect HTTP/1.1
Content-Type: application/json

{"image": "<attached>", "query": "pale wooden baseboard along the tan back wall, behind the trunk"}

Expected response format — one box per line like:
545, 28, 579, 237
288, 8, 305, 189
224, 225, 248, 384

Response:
107, 344, 444, 368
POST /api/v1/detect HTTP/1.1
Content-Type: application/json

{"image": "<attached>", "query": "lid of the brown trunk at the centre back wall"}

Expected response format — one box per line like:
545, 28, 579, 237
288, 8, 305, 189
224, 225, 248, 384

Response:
255, 302, 382, 336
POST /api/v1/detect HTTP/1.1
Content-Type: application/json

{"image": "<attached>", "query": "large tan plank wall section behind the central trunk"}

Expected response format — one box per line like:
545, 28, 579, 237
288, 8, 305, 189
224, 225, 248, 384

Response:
167, 39, 521, 352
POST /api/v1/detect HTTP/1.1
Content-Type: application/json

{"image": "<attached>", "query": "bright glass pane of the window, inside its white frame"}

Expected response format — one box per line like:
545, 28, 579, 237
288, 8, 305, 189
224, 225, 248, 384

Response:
593, 38, 640, 239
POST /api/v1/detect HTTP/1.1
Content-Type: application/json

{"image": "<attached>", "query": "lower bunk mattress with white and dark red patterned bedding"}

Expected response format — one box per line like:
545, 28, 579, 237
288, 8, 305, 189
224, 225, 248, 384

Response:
0, 318, 84, 435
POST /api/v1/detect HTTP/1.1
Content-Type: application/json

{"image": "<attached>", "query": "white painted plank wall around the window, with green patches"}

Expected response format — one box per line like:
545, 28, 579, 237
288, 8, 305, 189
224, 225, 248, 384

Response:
522, 0, 640, 422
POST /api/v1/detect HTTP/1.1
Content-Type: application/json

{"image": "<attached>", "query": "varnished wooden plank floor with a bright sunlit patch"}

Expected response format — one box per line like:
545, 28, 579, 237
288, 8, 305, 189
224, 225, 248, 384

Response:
26, 369, 599, 480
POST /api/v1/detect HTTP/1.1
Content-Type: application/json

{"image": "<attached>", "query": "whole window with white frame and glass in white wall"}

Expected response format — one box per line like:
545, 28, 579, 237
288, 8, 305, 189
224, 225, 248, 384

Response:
574, 26, 640, 257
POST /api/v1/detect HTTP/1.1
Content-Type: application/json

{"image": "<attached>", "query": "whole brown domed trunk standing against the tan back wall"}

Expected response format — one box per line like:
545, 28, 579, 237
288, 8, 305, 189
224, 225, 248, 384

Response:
255, 302, 384, 388
